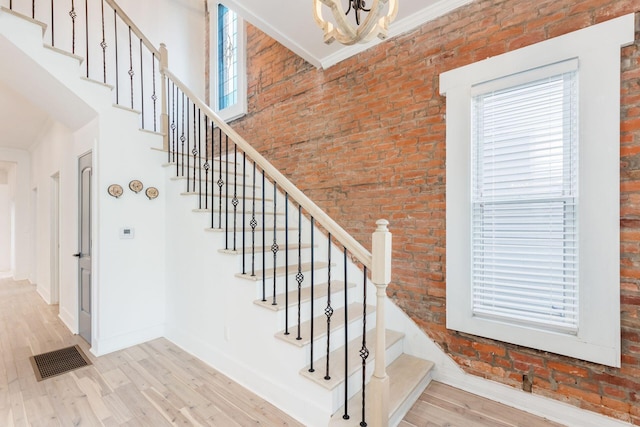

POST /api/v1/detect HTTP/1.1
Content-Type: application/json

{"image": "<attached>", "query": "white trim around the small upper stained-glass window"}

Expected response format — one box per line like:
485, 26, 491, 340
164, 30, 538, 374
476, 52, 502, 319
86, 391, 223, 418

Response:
209, 1, 247, 122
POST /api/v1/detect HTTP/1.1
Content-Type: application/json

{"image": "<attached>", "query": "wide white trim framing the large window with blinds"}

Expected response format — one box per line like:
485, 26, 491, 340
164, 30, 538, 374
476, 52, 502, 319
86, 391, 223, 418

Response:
440, 14, 635, 367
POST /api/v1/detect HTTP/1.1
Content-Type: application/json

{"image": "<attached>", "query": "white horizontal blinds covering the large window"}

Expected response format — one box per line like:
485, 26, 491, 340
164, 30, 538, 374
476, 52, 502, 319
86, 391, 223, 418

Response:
471, 70, 578, 333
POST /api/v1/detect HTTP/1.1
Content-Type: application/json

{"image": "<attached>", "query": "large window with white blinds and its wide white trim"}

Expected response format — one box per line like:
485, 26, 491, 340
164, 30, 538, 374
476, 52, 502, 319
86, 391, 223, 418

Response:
439, 14, 635, 367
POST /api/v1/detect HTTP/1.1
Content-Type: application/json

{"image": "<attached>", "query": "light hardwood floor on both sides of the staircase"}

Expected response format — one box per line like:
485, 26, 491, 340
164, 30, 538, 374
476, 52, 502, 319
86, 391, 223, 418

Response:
0, 278, 558, 427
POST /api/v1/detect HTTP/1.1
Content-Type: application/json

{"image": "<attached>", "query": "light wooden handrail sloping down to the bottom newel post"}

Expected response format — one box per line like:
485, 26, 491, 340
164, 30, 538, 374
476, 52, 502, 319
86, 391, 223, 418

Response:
161, 69, 372, 269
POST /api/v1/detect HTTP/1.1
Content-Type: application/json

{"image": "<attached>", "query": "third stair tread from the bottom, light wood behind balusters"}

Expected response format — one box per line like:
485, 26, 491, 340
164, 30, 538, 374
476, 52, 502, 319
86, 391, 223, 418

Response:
276, 303, 376, 351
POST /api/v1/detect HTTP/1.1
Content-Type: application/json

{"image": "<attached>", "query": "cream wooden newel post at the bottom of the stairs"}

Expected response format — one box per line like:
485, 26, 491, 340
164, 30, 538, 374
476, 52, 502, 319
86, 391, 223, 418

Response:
369, 219, 391, 427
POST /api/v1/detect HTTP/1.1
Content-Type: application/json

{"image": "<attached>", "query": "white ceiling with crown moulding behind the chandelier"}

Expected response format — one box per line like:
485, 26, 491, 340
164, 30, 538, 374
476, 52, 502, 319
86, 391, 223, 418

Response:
225, 0, 472, 68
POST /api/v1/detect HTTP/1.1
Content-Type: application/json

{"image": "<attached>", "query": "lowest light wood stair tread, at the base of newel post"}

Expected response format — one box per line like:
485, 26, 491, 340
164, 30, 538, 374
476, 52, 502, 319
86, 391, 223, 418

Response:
329, 354, 434, 427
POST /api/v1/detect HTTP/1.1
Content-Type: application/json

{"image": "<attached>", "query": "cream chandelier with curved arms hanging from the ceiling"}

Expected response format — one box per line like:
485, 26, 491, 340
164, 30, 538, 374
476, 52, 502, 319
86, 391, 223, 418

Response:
313, 0, 398, 45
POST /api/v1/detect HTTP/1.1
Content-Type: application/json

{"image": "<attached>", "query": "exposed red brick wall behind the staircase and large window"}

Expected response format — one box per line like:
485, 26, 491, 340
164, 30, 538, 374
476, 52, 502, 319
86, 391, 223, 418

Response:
230, 0, 640, 425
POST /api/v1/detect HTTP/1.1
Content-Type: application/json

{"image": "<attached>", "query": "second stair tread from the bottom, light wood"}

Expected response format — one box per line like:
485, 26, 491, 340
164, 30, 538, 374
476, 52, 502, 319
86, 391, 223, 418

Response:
300, 329, 404, 390
